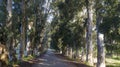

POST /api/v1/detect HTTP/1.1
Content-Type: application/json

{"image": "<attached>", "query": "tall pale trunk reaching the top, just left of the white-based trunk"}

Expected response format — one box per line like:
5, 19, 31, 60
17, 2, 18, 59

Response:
86, 0, 93, 66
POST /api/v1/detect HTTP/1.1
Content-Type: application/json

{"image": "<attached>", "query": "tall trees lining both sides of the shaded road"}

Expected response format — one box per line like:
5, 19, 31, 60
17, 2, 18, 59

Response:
0, 0, 120, 67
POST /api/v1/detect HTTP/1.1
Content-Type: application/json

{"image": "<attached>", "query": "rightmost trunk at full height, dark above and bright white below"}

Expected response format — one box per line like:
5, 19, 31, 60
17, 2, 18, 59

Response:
96, 0, 105, 67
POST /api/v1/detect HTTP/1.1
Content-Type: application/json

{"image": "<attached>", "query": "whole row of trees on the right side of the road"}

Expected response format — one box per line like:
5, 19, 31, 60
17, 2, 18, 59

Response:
51, 0, 119, 67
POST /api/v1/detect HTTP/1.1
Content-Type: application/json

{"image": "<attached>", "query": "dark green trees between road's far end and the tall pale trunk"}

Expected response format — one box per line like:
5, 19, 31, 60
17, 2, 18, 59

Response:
51, 0, 83, 58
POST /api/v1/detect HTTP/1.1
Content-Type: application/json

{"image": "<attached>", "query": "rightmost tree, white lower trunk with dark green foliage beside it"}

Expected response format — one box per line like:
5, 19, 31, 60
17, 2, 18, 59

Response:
96, 0, 120, 67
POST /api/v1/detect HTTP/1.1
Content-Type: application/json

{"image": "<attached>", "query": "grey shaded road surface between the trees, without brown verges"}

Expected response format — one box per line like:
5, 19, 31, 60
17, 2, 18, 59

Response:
32, 49, 76, 67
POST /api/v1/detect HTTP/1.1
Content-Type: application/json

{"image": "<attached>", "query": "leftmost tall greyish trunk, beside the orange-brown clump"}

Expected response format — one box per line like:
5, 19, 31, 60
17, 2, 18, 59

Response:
6, 0, 14, 61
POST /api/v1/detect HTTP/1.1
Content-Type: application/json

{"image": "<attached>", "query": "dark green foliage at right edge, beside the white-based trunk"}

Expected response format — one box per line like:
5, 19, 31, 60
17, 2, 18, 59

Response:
100, 0, 120, 55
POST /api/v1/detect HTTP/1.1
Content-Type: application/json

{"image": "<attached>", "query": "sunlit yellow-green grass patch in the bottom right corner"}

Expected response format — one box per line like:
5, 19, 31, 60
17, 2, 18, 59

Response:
106, 56, 120, 67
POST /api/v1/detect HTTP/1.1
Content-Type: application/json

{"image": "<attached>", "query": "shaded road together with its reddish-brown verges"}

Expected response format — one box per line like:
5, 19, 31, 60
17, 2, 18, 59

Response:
20, 49, 89, 67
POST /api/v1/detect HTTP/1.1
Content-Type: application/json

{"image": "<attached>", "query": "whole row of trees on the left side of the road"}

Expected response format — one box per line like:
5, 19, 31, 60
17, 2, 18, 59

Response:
0, 0, 49, 67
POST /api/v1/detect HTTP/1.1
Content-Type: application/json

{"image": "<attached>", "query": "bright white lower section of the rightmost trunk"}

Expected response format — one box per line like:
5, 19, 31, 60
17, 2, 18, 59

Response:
97, 32, 105, 67
